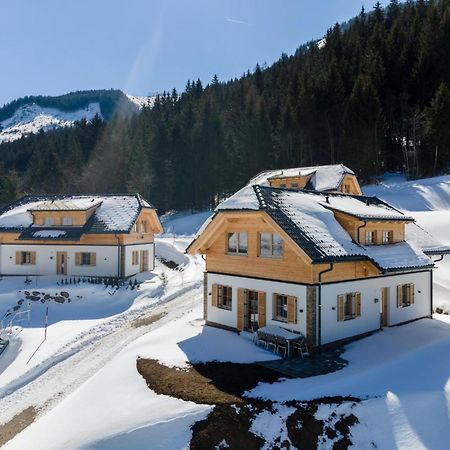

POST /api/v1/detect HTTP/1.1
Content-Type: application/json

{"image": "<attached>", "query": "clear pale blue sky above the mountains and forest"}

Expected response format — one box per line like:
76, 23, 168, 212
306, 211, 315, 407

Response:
0, 0, 388, 105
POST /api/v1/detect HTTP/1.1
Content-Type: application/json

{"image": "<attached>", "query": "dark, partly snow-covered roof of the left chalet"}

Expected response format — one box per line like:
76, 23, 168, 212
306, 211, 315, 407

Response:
0, 194, 153, 236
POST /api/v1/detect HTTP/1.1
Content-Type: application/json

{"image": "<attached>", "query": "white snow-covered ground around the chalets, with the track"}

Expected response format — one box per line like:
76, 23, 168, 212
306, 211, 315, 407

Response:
0, 177, 450, 449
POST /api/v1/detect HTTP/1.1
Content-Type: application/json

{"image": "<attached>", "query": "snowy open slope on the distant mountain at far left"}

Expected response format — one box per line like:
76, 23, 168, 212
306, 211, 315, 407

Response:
0, 103, 102, 144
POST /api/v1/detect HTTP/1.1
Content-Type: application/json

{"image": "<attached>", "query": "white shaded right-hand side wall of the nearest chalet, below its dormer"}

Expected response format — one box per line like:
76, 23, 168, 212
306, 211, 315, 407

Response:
321, 272, 430, 344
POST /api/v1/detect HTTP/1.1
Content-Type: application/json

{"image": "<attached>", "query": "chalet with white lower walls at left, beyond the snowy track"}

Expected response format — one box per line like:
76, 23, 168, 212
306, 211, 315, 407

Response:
0, 194, 162, 278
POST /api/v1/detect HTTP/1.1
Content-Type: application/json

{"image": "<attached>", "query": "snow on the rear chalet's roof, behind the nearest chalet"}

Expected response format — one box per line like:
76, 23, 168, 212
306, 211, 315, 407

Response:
249, 164, 355, 191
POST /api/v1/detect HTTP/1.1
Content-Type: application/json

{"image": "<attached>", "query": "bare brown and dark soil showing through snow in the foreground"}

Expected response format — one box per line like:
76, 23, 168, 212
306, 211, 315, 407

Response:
137, 359, 360, 450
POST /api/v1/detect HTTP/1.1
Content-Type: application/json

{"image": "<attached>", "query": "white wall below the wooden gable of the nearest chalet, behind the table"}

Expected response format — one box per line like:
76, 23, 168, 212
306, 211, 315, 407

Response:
207, 273, 306, 334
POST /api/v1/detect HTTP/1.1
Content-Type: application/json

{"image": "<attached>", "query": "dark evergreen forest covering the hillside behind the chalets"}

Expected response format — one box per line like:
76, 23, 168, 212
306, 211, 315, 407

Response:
0, 0, 450, 211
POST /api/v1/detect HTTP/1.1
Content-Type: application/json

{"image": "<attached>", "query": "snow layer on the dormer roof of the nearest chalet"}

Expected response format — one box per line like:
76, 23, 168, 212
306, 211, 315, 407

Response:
320, 195, 414, 221
